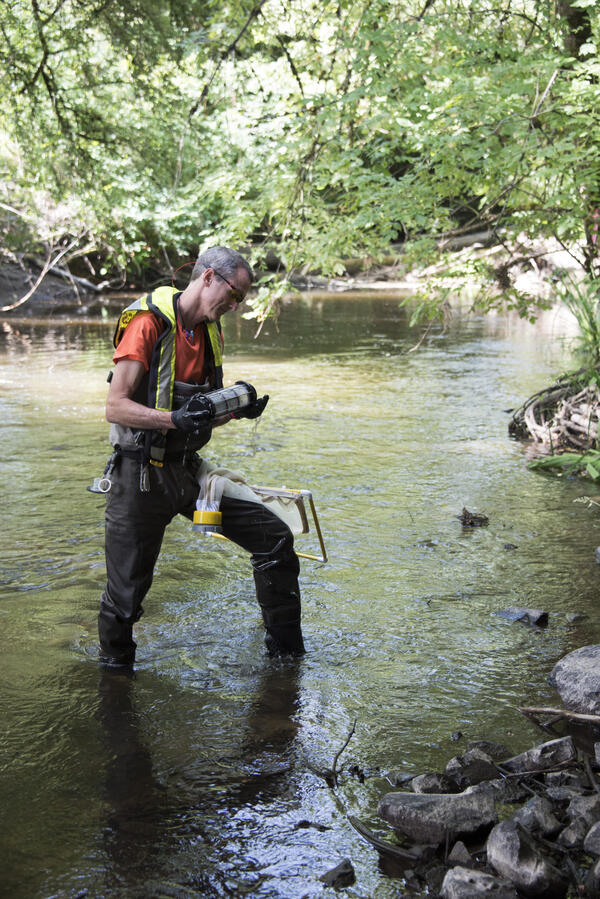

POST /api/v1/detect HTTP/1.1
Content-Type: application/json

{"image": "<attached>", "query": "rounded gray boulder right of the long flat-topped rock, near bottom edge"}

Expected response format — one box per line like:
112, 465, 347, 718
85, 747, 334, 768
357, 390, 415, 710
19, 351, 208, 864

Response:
486, 821, 568, 899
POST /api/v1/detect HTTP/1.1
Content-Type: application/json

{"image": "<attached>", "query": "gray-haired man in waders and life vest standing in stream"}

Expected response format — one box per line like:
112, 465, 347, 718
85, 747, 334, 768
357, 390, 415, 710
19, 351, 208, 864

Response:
98, 247, 304, 666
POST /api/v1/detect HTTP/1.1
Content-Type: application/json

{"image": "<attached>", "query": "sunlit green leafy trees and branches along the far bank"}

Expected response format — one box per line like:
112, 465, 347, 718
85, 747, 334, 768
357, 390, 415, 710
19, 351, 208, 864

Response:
0, 0, 600, 326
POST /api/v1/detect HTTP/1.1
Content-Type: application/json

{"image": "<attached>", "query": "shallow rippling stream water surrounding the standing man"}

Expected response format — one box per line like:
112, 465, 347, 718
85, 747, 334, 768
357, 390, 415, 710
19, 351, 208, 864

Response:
0, 296, 600, 899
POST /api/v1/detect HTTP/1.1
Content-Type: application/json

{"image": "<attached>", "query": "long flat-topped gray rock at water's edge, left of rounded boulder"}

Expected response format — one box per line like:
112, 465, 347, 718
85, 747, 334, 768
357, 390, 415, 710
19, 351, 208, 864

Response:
378, 790, 497, 845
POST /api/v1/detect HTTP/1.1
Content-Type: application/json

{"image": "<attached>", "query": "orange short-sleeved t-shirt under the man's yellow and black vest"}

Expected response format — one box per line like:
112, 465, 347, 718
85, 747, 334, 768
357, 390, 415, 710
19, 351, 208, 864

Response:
113, 312, 214, 384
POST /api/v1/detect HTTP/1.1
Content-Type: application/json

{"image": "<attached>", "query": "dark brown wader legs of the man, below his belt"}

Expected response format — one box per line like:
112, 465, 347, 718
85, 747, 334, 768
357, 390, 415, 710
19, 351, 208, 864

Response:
98, 454, 304, 665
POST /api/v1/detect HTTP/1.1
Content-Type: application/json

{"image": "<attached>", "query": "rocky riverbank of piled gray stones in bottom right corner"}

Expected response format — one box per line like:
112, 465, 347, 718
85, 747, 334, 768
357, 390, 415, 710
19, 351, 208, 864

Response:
353, 646, 600, 899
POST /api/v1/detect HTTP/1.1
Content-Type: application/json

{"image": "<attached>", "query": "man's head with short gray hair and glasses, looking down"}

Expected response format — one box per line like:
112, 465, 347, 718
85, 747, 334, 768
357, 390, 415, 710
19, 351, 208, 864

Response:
182, 247, 254, 321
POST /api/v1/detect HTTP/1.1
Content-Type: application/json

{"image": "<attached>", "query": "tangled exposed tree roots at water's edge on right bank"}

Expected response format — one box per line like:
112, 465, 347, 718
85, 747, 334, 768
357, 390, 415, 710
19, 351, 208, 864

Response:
508, 370, 600, 452
